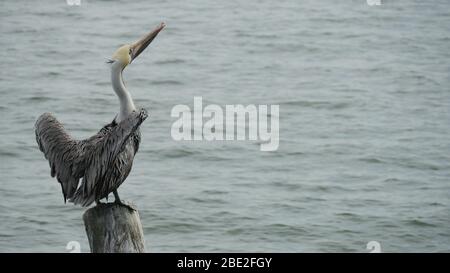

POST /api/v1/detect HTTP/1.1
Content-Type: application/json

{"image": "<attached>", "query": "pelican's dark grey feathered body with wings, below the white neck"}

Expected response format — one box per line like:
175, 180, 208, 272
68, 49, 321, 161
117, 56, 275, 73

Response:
35, 109, 147, 206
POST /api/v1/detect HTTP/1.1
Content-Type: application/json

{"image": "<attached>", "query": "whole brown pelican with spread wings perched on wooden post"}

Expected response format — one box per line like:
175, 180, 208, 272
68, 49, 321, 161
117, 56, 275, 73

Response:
35, 23, 165, 206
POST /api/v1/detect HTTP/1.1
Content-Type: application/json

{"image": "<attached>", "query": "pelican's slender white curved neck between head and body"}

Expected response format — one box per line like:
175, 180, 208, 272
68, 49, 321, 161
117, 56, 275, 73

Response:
111, 61, 136, 123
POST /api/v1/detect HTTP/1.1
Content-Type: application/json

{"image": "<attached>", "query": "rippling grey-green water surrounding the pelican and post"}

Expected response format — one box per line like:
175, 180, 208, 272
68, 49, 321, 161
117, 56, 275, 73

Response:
0, 0, 450, 252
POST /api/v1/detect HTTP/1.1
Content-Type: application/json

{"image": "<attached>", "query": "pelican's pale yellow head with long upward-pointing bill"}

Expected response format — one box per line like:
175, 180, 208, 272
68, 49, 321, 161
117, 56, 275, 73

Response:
110, 23, 166, 68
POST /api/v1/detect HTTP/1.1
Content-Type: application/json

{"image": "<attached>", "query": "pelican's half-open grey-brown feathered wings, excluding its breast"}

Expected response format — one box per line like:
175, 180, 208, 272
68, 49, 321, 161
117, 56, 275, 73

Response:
35, 109, 147, 206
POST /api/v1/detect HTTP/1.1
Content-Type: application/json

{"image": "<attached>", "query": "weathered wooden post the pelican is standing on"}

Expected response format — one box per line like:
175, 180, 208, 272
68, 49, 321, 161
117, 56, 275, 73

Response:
83, 203, 145, 253
